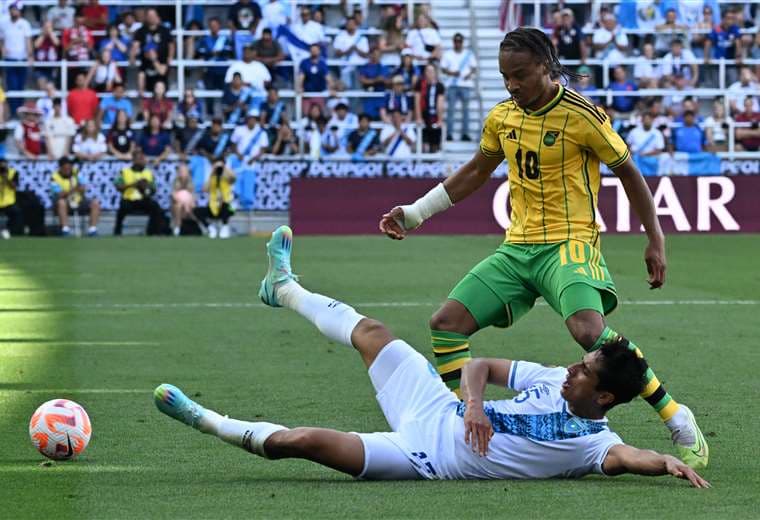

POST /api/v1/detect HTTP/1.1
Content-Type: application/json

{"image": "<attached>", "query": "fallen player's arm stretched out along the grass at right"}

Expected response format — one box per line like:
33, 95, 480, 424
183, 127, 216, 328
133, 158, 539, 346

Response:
602, 444, 710, 488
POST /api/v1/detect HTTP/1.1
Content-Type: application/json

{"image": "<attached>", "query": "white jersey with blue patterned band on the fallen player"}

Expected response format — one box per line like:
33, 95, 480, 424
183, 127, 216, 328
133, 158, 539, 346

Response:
404, 361, 623, 479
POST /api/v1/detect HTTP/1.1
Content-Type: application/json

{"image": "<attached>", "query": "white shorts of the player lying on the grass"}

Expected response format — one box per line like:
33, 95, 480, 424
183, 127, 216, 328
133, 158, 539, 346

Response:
359, 340, 459, 480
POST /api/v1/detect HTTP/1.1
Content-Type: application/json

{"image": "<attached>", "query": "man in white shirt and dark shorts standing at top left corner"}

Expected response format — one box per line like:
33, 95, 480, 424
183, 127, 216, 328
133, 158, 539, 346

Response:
0, 2, 34, 114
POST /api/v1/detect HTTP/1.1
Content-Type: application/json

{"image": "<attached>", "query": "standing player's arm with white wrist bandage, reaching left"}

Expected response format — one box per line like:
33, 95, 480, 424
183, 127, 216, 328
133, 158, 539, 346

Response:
380, 150, 504, 240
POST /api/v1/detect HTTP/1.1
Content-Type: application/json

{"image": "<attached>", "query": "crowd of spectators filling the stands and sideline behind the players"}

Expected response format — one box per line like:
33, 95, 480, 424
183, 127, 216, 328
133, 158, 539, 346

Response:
0, 0, 760, 239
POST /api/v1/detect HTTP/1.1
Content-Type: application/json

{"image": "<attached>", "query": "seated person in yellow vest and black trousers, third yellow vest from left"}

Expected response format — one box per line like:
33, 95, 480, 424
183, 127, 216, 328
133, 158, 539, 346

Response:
113, 149, 166, 236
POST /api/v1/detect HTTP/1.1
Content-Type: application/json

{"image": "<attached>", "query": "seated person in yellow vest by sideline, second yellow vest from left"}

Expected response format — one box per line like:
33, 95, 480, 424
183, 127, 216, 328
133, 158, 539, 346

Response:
50, 156, 100, 237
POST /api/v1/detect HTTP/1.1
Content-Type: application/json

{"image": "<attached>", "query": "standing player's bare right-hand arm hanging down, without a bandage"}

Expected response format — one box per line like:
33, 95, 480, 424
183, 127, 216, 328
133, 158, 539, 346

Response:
612, 158, 666, 289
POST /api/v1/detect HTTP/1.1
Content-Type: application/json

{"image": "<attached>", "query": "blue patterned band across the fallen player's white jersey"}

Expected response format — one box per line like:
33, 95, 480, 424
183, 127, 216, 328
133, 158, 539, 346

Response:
457, 402, 607, 441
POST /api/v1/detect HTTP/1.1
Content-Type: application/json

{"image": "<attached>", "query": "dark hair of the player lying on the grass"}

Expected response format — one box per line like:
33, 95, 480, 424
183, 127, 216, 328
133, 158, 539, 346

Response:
596, 342, 649, 410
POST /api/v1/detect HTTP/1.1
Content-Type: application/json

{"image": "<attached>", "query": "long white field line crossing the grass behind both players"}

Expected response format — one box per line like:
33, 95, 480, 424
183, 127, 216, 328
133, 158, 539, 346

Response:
0, 300, 760, 312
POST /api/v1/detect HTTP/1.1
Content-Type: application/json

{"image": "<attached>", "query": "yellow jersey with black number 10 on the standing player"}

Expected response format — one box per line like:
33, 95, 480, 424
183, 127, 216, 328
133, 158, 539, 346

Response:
480, 85, 630, 246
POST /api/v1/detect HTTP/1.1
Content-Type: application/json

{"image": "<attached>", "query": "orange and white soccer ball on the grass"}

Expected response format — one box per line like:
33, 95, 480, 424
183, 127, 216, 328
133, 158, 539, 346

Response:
29, 399, 92, 460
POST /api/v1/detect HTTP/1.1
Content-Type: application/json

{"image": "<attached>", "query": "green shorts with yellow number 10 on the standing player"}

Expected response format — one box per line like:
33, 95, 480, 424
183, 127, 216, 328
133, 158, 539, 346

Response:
449, 240, 617, 328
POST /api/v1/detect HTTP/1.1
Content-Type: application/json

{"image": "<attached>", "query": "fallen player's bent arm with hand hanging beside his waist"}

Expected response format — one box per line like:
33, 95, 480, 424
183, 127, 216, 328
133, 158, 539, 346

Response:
461, 358, 512, 456
